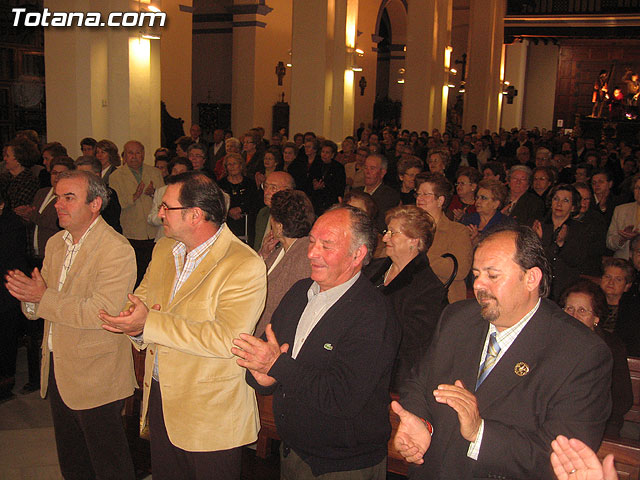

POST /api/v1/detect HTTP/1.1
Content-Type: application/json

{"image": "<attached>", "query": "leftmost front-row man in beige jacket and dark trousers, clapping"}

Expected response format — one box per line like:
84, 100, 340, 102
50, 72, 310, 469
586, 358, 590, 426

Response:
6, 171, 136, 479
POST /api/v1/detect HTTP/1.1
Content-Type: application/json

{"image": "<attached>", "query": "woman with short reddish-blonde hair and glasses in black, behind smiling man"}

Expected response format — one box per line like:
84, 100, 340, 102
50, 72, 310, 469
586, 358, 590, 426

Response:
365, 205, 448, 384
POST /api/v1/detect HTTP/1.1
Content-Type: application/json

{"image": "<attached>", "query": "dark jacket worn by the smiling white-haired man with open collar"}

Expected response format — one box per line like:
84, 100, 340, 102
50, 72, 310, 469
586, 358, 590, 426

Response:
247, 276, 400, 475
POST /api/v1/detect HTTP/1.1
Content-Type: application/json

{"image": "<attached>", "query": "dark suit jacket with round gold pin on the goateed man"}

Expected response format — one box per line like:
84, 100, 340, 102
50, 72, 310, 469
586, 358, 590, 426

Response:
400, 299, 613, 480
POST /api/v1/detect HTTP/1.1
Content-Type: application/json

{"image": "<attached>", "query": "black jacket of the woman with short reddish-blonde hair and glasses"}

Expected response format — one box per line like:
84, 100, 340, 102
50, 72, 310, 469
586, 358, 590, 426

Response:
364, 253, 449, 383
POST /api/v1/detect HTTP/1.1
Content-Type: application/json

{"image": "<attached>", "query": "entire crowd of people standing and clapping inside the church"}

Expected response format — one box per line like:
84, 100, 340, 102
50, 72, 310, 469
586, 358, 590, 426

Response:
0, 125, 640, 478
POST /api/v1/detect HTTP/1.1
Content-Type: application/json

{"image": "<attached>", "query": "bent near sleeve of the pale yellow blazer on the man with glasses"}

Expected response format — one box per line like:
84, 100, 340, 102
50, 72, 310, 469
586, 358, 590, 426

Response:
144, 248, 267, 358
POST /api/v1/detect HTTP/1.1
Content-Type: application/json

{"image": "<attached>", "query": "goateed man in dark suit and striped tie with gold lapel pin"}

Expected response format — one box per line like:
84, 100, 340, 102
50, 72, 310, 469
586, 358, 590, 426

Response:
392, 225, 612, 479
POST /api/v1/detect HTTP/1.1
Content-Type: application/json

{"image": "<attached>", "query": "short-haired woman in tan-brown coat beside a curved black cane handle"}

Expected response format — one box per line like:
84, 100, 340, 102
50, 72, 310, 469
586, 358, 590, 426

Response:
416, 173, 472, 303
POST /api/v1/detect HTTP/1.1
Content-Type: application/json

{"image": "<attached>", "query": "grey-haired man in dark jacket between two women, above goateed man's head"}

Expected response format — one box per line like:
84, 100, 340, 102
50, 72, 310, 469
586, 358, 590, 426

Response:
502, 165, 544, 227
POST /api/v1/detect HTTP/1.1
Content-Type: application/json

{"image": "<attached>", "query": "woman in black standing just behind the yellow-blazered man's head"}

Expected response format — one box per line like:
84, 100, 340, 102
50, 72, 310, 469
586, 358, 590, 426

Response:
218, 153, 259, 244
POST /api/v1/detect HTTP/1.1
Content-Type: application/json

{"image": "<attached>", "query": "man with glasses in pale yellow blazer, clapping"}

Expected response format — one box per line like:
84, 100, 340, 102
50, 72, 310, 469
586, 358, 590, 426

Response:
101, 171, 266, 480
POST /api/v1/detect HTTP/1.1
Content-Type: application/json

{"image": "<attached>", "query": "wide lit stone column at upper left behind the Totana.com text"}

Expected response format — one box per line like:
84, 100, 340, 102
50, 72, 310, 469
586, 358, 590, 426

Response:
45, 0, 168, 162
